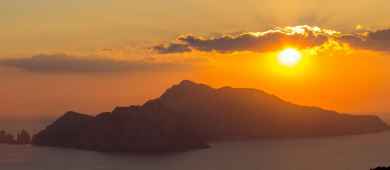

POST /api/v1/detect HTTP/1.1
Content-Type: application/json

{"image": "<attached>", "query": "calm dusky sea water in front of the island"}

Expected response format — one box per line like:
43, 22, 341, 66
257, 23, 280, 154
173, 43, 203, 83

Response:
0, 132, 390, 170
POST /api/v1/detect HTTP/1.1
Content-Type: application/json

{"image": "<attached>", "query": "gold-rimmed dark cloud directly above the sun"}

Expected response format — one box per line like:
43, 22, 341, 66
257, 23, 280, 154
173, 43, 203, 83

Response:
154, 25, 337, 54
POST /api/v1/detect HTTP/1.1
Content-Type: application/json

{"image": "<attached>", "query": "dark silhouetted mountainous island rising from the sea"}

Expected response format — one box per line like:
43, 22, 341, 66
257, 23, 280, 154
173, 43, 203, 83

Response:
33, 81, 388, 152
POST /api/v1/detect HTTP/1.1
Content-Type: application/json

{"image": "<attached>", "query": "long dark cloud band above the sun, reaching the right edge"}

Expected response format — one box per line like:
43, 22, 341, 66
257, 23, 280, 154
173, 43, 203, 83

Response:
154, 26, 390, 54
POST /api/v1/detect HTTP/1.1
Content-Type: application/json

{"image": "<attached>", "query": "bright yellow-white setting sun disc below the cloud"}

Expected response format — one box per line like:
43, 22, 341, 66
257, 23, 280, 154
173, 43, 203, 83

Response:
278, 48, 302, 67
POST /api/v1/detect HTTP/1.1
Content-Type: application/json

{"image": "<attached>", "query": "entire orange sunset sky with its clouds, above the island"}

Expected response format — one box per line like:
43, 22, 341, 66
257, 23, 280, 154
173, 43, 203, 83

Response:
0, 0, 390, 123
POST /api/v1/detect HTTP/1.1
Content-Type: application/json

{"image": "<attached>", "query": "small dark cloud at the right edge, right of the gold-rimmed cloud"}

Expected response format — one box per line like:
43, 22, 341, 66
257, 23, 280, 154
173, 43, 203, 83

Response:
339, 29, 390, 52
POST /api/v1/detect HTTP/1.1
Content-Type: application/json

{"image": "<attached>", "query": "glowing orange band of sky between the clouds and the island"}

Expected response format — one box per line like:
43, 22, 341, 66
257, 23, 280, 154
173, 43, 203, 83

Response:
0, 37, 390, 117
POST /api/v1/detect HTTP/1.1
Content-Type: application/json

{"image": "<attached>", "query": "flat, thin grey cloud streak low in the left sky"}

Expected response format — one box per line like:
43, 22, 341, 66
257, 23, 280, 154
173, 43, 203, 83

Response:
0, 54, 187, 73
